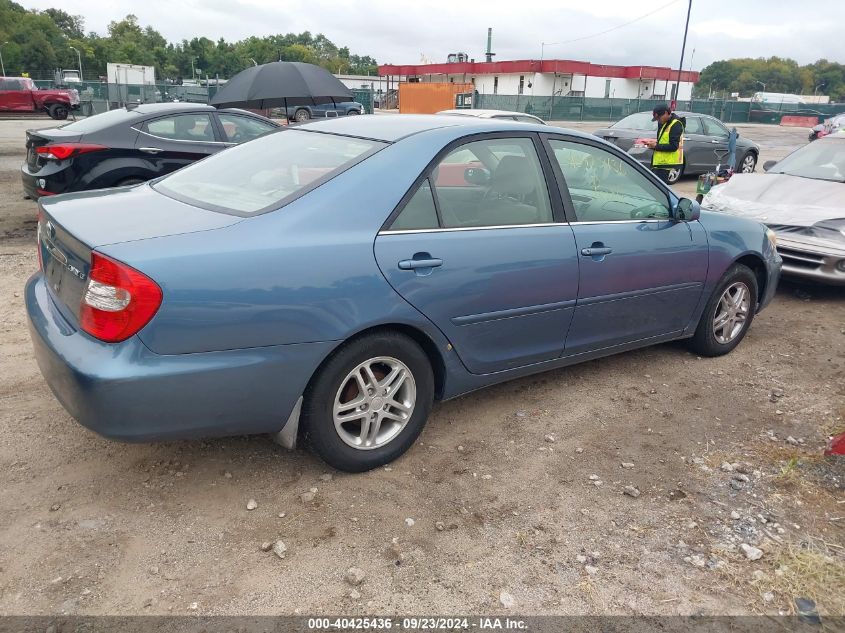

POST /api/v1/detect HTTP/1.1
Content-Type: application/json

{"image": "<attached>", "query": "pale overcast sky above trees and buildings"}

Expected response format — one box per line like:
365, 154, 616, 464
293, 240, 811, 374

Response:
17, 0, 845, 70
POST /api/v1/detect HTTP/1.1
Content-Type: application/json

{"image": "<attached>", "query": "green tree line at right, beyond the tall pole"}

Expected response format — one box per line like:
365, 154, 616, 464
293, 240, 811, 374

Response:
695, 57, 845, 101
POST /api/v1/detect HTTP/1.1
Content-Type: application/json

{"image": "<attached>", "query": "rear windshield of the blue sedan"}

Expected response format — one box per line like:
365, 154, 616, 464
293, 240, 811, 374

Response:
154, 130, 386, 215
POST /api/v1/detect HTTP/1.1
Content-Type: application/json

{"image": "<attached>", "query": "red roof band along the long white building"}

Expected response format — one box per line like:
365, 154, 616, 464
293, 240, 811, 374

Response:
378, 59, 699, 83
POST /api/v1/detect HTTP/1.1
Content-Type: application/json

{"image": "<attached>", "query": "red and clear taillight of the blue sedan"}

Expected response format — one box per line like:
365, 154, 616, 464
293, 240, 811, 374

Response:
79, 252, 161, 343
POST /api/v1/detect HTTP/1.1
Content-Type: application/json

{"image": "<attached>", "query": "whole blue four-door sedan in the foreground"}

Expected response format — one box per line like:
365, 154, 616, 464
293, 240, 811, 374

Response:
26, 116, 781, 471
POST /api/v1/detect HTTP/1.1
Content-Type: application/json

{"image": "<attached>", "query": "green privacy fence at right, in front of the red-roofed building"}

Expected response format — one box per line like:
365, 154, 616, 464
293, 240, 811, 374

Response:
475, 94, 845, 124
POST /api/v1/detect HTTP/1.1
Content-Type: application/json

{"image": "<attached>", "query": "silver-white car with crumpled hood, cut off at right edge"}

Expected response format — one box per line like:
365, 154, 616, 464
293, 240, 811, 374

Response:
703, 131, 845, 285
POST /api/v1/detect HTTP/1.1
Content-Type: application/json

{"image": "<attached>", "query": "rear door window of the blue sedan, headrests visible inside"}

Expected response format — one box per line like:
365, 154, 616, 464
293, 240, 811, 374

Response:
432, 138, 553, 228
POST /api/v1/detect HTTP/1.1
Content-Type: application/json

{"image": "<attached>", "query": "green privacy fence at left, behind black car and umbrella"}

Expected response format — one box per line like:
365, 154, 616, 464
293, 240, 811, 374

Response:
35, 80, 373, 116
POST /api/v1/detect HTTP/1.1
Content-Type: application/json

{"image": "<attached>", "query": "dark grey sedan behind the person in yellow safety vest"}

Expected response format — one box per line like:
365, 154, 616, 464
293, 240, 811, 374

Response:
595, 112, 760, 184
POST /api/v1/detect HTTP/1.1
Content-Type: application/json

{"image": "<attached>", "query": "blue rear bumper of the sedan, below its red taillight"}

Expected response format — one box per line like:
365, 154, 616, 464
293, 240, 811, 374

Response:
26, 273, 335, 441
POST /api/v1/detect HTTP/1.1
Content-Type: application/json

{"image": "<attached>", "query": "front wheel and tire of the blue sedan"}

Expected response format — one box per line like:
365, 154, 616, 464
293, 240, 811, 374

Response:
690, 264, 757, 357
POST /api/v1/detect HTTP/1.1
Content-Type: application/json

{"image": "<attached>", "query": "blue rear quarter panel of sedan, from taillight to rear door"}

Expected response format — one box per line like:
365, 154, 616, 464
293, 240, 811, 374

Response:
100, 134, 468, 354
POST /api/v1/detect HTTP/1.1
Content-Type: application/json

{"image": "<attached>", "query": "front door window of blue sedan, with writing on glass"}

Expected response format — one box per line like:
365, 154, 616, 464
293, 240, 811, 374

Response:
550, 140, 671, 222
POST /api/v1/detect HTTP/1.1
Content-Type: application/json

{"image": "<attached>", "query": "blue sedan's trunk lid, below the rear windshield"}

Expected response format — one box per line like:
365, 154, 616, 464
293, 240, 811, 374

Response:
38, 185, 243, 323
